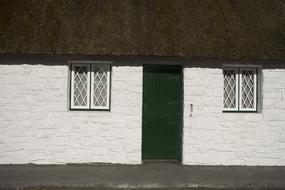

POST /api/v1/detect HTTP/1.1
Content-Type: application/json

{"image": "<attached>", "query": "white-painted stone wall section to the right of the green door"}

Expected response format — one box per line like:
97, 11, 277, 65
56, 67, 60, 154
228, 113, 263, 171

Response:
183, 66, 285, 166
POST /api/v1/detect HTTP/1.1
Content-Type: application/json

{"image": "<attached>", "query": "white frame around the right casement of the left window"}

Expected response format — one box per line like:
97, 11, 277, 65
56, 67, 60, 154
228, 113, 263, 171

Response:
91, 64, 111, 110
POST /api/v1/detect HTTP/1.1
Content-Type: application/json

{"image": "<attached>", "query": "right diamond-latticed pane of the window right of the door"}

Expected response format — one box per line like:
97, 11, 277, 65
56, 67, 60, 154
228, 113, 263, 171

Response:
241, 71, 254, 108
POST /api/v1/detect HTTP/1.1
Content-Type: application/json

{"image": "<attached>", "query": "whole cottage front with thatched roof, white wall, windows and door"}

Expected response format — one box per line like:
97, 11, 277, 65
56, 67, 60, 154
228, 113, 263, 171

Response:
0, 1, 285, 165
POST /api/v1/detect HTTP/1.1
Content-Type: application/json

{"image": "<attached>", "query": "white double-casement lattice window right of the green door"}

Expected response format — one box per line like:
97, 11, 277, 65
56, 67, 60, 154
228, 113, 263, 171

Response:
223, 68, 257, 111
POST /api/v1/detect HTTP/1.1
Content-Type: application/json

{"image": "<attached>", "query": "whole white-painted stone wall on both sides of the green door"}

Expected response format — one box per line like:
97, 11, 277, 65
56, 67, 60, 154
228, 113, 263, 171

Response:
0, 61, 285, 165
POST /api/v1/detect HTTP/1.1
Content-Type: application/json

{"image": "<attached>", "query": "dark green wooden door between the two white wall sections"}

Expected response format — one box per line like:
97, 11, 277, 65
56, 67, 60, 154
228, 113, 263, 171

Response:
142, 66, 182, 161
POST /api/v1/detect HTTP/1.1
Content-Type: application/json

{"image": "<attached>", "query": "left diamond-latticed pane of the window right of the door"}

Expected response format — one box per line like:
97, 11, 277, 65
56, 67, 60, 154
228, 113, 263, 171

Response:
224, 70, 236, 108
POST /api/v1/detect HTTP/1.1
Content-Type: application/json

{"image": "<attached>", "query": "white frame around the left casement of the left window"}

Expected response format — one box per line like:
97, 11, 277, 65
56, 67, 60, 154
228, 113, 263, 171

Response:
70, 64, 90, 109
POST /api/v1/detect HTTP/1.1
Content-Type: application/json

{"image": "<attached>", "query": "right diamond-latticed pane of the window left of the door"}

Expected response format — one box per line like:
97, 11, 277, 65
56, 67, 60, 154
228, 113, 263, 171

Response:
92, 67, 109, 107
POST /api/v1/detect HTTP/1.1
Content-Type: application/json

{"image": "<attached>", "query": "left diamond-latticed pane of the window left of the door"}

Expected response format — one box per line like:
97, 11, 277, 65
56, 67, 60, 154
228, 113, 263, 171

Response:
73, 66, 88, 106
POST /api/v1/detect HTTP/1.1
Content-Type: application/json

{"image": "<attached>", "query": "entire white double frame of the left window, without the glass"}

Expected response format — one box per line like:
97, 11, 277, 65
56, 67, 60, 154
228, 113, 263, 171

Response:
69, 61, 111, 111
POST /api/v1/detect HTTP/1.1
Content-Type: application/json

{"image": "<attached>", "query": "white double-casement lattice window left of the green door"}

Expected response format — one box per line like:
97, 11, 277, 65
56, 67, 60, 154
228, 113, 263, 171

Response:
70, 63, 110, 110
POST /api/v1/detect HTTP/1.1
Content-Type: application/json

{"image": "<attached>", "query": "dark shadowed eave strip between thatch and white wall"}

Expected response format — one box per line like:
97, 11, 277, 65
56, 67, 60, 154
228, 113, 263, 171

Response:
0, 54, 285, 69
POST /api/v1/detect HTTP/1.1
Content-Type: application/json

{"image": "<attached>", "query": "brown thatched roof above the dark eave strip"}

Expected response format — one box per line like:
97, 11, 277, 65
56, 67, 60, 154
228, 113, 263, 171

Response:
0, 0, 285, 59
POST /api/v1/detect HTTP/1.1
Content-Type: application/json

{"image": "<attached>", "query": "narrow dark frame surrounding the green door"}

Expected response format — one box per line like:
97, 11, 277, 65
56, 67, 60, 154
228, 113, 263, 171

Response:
141, 64, 184, 164
